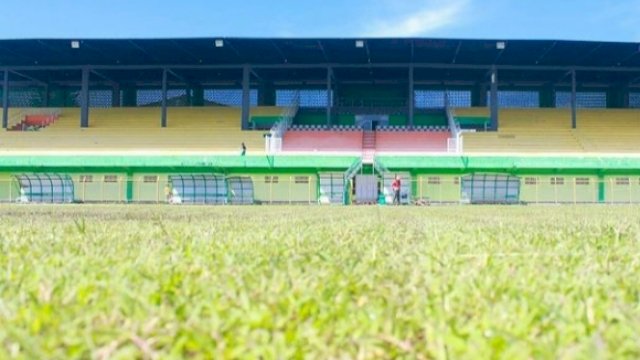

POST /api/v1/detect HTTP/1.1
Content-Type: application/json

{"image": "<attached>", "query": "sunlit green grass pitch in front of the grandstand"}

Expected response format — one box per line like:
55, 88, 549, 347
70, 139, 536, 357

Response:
0, 205, 640, 359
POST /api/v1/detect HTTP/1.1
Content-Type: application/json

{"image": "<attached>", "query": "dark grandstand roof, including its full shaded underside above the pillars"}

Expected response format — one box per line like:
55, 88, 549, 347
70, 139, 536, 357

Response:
0, 38, 640, 85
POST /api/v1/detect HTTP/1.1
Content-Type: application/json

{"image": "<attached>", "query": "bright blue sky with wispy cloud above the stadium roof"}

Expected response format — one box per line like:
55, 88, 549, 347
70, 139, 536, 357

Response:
0, 0, 640, 42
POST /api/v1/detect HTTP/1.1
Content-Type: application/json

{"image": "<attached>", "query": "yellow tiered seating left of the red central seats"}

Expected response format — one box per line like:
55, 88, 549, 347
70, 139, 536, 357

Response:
0, 107, 280, 153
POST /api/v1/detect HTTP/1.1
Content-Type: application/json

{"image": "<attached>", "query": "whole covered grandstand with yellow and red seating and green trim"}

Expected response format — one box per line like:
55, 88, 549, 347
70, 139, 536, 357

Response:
0, 38, 640, 204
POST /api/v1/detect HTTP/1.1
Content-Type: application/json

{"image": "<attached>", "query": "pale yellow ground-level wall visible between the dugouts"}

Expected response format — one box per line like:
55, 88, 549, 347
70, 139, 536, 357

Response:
0, 174, 640, 205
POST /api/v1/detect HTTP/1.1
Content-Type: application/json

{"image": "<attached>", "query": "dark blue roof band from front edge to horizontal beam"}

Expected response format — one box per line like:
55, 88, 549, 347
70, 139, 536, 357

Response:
0, 38, 640, 68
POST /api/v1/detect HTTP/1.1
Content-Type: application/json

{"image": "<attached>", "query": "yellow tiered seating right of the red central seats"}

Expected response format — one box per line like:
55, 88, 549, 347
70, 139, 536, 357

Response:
455, 108, 640, 153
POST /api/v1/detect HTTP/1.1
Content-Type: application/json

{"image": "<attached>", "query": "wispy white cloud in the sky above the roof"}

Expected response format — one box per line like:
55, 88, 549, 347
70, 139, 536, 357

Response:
363, 0, 468, 37
